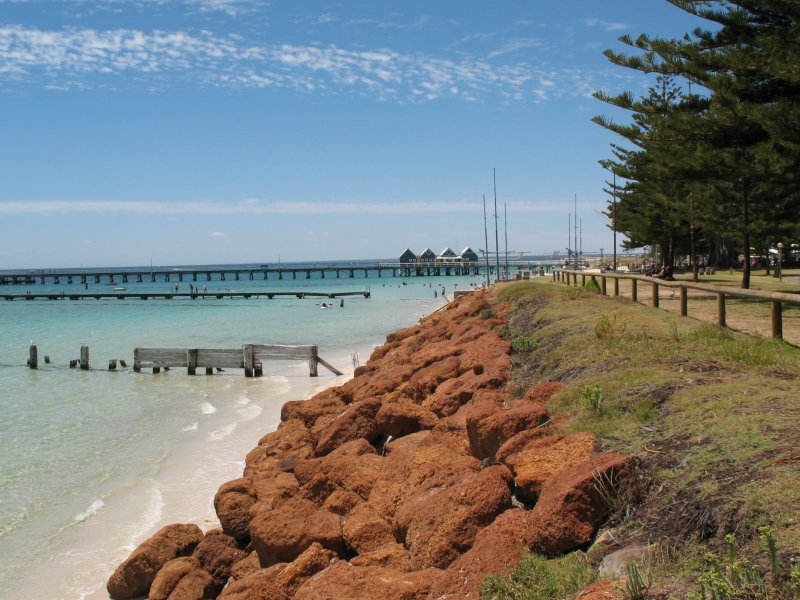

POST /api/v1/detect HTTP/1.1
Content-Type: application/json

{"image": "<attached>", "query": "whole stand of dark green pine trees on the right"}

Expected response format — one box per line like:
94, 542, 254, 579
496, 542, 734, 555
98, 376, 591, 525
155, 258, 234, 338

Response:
594, 0, 800, 288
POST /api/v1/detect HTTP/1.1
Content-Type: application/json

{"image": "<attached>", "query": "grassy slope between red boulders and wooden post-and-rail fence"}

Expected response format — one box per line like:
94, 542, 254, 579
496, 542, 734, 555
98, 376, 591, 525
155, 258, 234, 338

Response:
492, 283, 800, 597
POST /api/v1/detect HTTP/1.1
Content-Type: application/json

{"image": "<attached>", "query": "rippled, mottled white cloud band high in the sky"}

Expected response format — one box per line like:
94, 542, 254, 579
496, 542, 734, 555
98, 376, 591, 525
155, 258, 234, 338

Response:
0, 23, 600, 101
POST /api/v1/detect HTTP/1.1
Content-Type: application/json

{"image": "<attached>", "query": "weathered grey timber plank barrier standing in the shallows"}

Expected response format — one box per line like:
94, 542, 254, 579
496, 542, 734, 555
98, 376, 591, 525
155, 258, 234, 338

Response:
133, 344, 342, 377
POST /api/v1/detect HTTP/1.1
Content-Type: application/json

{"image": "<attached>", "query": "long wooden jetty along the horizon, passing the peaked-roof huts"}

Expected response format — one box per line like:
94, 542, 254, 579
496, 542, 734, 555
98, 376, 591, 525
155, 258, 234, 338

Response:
0, 261, 552, 285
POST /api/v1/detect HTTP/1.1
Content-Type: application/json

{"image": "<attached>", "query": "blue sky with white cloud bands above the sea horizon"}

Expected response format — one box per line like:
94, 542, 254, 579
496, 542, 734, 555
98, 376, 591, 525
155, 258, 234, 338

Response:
0, 0, 698, 269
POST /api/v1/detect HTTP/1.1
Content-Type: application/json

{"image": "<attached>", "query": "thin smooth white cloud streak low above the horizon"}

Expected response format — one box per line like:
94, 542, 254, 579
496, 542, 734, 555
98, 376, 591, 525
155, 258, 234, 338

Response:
0, 198, 563, 216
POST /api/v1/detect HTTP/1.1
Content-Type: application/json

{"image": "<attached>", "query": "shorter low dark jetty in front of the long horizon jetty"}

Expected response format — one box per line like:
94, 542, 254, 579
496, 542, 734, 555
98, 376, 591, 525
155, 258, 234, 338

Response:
0, 290, 371, 300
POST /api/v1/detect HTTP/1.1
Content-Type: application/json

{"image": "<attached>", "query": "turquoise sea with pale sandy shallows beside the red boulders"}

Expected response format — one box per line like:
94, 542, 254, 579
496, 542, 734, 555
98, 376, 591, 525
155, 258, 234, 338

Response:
0, 269, 481, 600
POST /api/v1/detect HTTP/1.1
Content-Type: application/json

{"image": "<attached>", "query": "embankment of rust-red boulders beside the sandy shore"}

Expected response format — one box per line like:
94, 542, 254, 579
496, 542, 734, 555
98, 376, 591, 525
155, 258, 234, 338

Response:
108, 293, 626, 600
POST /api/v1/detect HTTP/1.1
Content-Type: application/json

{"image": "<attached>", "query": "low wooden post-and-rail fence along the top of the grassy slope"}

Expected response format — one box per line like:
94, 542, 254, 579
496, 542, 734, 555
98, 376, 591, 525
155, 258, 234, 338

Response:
553, 269, 800, 339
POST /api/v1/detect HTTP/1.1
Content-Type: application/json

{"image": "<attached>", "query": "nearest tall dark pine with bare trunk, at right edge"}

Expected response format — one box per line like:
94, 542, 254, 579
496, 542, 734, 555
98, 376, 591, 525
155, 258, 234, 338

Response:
598, 0, 800, 288
